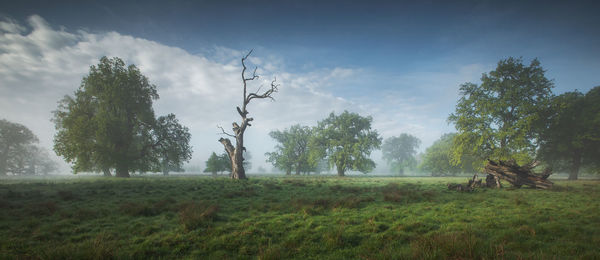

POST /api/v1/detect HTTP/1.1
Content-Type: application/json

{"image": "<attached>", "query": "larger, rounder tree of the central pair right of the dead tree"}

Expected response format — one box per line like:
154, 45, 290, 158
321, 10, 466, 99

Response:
310, 111, 381, 176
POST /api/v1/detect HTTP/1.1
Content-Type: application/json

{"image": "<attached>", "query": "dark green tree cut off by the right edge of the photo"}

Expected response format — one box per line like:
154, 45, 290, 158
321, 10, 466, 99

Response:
538, 87, 600, 180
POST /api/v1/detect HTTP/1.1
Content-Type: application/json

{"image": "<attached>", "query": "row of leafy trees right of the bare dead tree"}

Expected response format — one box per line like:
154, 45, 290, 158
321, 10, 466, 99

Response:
209, 57, 600, 179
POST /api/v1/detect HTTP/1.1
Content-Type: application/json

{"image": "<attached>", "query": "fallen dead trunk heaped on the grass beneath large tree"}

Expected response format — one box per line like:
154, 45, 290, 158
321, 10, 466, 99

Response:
485, 160, 553, 189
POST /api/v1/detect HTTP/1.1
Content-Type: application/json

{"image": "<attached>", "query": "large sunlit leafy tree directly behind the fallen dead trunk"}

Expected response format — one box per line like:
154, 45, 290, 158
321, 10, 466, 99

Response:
448, 58, 554, 168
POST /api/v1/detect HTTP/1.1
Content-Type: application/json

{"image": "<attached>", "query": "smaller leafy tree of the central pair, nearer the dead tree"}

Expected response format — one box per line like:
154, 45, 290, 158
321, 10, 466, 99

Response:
265, 124, 316, 175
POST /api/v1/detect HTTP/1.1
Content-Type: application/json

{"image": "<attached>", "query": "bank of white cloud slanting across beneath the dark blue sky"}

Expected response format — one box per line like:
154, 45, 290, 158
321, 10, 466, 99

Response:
0, 15, 478, 173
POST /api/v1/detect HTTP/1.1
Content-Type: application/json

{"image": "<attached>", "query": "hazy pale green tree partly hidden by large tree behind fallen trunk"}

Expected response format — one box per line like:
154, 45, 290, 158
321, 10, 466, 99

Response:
419, 133, 474, 176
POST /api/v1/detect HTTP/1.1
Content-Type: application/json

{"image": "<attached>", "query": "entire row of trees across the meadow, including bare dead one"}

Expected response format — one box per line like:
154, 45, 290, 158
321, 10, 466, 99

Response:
0, 51, 600, 179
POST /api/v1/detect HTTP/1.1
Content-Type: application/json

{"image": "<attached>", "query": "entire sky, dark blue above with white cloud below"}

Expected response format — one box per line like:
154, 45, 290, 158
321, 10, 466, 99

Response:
0, 0, 600, 172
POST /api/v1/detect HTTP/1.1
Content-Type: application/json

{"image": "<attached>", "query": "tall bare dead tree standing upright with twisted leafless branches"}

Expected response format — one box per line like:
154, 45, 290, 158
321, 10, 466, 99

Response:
219, 50, 279, 179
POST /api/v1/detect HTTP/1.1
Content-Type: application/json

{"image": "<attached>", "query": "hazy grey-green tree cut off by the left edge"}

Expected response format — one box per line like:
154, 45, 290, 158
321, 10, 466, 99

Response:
0, 119, 38, 175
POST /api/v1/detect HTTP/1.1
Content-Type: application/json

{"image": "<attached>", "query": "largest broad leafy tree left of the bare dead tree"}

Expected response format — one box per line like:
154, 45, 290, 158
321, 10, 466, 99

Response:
53, 57, 189, 177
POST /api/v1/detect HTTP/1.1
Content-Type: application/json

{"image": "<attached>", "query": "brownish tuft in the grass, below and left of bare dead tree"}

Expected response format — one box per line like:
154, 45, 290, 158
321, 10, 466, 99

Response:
179, 202, 219, 231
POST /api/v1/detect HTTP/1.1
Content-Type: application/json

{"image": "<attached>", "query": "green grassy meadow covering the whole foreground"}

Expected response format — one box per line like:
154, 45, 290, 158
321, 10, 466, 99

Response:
0, 176, 600, 259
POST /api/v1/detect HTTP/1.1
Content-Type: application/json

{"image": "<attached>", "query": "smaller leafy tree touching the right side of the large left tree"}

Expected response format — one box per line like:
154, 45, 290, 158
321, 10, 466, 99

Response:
155, 114, 192, 175
